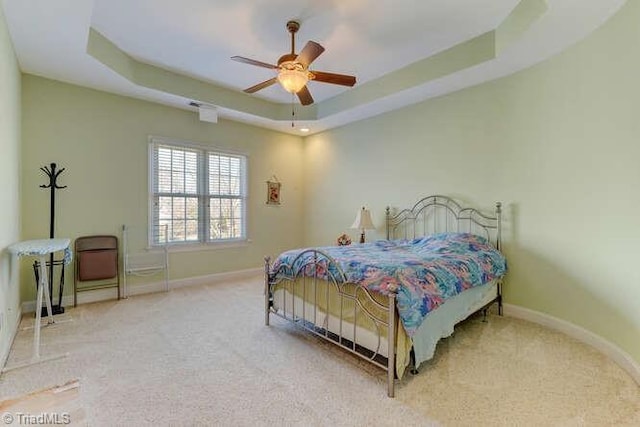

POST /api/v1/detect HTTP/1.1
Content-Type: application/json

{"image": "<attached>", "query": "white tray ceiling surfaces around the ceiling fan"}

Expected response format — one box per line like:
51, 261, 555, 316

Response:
3, 0, 625, 133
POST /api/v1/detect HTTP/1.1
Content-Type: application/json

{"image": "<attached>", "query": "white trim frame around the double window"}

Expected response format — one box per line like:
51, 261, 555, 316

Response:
147, 135, 252, 252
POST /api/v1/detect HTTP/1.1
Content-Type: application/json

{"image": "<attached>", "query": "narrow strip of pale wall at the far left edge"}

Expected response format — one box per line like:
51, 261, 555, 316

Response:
0, 3, 20, 366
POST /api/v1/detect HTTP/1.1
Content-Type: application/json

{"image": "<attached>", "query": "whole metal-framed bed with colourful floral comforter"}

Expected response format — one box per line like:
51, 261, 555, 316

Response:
265, 195, 506, 397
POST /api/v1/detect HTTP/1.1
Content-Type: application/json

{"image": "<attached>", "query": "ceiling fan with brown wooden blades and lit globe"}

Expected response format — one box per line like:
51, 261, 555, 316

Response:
231, 21, 356, 105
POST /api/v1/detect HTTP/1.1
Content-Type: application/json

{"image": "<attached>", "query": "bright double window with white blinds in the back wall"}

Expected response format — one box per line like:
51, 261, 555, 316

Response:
149, 138, 247, 245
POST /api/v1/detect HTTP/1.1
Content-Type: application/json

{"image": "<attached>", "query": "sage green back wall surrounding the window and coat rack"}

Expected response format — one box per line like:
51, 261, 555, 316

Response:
22, 75, 303, 301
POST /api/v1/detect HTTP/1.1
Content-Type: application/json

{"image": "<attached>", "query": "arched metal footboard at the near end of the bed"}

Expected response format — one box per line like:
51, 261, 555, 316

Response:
264, 249, 397, 397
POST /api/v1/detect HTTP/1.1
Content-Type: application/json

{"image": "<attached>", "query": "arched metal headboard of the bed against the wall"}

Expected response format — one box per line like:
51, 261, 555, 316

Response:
386, 195, 502, 250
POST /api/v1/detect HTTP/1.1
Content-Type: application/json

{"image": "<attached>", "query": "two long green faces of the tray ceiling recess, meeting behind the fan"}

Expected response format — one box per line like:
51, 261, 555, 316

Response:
87, 28, 504, 121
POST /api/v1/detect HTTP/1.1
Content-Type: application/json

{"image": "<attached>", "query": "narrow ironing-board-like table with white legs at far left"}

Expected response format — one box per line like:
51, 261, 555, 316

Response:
2, 238, 72, 372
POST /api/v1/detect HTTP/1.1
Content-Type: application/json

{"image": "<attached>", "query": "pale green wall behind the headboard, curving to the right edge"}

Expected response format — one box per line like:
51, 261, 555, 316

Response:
305, 1, 640, 362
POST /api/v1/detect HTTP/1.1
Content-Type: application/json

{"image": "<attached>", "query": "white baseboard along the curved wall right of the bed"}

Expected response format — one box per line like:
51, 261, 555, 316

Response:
504, 304, 640, 385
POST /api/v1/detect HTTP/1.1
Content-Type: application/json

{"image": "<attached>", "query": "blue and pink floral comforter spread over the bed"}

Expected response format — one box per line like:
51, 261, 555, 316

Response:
271, 233, 507, 336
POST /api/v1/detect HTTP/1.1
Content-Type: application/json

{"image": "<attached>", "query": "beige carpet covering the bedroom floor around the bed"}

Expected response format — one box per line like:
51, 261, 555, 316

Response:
0, 277, 640, 426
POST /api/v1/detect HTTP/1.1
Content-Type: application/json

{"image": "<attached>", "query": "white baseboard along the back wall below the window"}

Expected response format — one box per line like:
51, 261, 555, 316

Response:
22, 267, 264, 313
